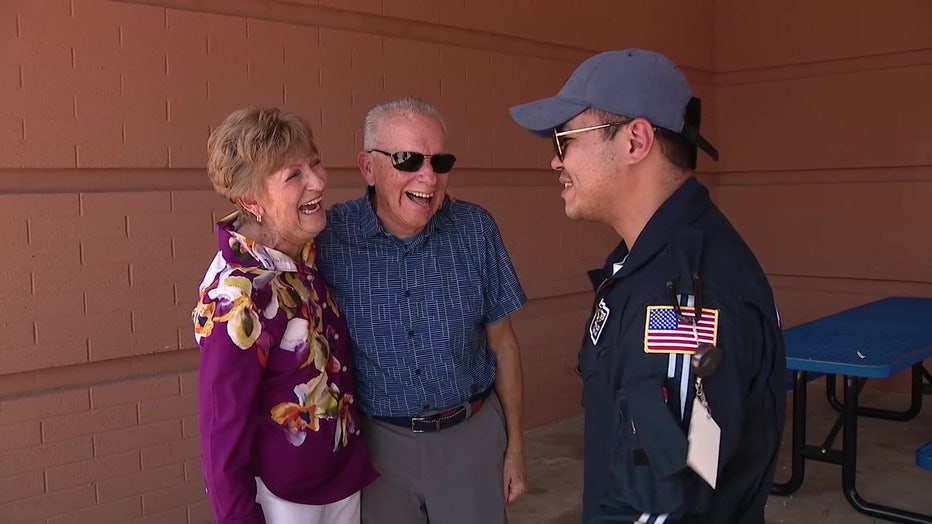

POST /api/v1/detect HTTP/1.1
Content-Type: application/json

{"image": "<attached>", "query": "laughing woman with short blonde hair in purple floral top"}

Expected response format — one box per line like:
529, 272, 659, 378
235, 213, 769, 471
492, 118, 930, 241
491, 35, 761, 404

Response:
193, 108, 377, 524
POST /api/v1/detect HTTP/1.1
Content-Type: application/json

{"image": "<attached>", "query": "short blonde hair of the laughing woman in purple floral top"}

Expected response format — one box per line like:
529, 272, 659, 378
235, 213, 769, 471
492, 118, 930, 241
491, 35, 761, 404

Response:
207, 107, 317, 215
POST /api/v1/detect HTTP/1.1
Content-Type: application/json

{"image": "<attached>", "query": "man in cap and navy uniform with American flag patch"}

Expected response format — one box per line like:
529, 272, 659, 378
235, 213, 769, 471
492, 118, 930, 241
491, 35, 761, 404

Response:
511, 49, 786, 524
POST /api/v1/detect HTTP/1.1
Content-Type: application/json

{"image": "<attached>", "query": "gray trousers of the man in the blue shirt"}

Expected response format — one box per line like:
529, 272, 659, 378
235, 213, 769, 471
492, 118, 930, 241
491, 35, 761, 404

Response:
362, 392, 507, 524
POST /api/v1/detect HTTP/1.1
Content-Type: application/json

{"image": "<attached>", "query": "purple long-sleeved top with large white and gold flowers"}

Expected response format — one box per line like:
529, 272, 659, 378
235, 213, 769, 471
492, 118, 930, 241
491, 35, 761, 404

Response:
193, 216, 378, 524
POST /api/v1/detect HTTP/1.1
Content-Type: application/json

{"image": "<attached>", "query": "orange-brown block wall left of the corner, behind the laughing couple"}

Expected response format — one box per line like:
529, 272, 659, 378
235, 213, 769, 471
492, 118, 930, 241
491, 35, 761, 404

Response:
0, 0, 713, 524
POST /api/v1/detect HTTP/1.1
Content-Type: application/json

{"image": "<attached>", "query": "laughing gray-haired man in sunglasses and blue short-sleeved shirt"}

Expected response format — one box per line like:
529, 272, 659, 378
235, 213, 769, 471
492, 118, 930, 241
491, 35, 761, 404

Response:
317, 98, 526, 524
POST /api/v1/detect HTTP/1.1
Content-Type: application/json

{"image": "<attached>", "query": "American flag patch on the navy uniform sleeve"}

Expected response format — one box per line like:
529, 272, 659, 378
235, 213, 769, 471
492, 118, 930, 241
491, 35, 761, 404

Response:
644, 306, 718, 355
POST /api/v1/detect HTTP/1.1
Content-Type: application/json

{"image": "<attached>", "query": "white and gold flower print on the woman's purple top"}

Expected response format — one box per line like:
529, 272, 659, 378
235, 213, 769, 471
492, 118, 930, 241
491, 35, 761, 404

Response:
193, 213, 356, 451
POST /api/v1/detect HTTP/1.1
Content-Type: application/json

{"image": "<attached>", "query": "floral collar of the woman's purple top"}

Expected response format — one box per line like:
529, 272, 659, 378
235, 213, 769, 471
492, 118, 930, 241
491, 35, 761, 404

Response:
217, 212, 317, 272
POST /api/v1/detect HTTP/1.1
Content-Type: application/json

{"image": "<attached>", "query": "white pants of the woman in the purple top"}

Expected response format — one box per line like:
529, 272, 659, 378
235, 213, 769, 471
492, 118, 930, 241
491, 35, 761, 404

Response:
256, 477, 359, 524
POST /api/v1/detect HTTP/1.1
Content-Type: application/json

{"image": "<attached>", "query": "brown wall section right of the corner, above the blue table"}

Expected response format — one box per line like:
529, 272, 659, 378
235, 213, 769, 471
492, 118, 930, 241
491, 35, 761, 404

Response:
710, 0, 932, 336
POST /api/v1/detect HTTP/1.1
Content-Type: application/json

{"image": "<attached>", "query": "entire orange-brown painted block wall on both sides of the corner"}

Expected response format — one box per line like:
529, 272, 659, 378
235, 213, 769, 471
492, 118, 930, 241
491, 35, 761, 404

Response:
0, 0, 932, 524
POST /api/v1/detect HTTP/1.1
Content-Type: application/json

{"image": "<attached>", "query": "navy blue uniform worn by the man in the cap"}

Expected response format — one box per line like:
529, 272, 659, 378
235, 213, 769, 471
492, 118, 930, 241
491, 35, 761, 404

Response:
579, 177, 786, 524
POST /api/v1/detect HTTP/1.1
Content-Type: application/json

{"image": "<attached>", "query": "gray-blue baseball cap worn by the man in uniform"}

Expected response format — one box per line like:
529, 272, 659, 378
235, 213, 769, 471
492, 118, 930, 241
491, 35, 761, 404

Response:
511, 49, 718, 160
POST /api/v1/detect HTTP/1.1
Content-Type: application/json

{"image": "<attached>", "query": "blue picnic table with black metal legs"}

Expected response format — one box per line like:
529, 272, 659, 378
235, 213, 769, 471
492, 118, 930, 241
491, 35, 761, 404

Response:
771, 297, 932, 524
